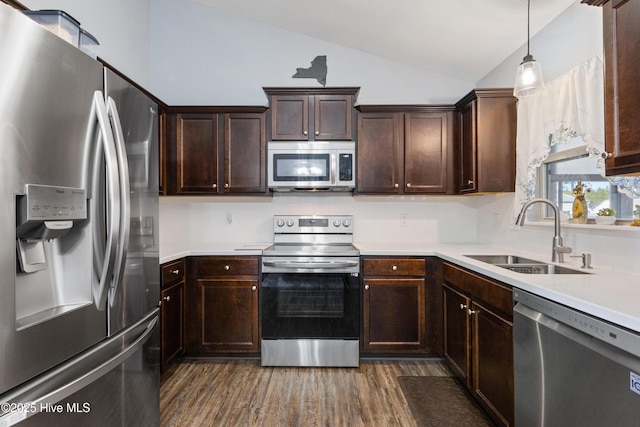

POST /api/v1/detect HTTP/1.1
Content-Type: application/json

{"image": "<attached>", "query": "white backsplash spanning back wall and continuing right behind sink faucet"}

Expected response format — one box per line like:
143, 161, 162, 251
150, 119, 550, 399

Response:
160, 193, 640, 274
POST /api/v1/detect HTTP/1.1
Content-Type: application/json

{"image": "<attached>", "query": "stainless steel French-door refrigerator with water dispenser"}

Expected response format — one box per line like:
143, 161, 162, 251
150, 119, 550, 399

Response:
0, 3, 159, 427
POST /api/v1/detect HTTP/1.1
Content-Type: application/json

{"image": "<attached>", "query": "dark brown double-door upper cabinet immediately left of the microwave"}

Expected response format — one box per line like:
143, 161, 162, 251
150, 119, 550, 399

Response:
164, 107, 268, 195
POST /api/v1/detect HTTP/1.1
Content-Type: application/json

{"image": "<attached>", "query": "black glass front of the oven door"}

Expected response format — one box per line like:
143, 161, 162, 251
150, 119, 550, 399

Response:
260, 273, 360, 339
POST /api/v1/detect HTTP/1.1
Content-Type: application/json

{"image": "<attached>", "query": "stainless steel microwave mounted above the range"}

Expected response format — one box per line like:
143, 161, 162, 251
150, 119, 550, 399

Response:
267, 141, 356, 191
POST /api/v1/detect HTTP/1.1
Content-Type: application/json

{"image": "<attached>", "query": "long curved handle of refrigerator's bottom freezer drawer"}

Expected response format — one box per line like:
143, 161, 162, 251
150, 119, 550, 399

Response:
0, 314, 158, 427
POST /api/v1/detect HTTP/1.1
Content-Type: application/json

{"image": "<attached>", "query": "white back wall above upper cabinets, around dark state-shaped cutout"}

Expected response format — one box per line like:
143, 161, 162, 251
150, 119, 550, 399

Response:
151, 0, 475, 105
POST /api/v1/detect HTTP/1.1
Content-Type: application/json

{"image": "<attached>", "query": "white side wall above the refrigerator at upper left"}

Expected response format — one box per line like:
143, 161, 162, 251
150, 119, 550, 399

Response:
20, 0, 151, 90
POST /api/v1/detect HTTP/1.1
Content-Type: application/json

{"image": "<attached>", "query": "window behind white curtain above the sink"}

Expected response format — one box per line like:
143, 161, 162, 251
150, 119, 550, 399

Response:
537, 137, 640, 220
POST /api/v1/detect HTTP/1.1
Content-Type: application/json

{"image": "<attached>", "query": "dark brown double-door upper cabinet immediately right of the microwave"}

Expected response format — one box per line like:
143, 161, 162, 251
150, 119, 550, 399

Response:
356, 106, 456, 194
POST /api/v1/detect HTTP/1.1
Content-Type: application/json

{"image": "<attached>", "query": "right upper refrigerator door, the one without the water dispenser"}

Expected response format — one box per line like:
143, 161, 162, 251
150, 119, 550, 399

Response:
104, 68, 160, 334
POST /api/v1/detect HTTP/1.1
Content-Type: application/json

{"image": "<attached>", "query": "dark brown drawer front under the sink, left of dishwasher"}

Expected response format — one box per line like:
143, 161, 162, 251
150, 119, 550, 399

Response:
442, 263, 513, 317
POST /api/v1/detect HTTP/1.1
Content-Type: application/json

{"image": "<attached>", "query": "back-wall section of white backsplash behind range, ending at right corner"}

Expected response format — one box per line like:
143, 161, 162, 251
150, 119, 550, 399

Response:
160, 193, 477, 245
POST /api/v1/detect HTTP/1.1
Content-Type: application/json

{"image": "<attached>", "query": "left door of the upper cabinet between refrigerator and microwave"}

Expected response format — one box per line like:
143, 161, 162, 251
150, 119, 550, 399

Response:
175, 114, 220, 194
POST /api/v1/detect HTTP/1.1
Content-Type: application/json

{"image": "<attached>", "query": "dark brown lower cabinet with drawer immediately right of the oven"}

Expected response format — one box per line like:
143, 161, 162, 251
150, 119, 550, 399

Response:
362, 258, 427, 355
